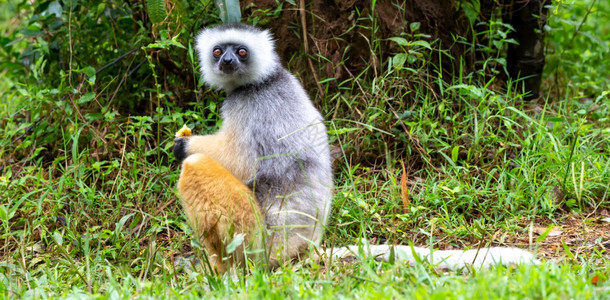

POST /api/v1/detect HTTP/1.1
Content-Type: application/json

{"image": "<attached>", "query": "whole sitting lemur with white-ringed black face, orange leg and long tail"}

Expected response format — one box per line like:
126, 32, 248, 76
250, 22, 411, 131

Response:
174, 24, 536, 267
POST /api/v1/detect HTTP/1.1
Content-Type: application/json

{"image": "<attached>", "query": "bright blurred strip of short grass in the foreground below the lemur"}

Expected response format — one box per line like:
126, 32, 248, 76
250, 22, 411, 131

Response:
2, 259, 608, 299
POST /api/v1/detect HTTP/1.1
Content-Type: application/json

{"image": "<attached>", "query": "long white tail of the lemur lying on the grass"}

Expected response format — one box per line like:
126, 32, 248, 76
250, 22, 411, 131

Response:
321, 244, 540, 269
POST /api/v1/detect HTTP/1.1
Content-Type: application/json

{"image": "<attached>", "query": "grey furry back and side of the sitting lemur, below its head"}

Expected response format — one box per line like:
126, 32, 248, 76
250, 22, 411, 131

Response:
221, 68, 332, 260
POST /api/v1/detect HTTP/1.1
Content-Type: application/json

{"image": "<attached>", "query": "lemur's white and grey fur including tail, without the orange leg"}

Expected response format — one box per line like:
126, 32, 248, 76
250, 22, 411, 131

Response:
174, 24, 537, 268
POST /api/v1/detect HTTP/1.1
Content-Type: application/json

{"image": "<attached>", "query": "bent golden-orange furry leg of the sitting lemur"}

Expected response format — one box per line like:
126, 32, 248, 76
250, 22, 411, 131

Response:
178, 154, 263, 273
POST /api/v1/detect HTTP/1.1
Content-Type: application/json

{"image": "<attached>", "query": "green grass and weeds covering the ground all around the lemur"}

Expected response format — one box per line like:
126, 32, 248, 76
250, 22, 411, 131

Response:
0, 1, 610, 299
